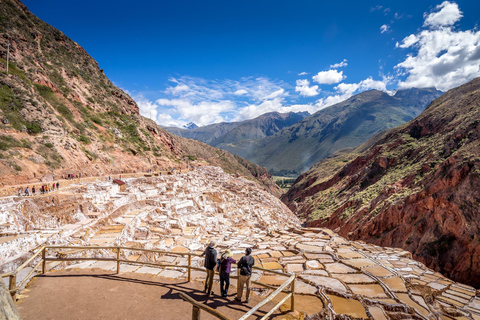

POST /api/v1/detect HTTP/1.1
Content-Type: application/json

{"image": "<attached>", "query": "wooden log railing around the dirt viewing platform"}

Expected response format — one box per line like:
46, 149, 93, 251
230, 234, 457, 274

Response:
0, 246, 295, 320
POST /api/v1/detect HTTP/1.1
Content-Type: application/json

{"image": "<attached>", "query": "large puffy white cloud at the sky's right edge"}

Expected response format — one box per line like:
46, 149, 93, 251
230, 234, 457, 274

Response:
395, 1, 480, 91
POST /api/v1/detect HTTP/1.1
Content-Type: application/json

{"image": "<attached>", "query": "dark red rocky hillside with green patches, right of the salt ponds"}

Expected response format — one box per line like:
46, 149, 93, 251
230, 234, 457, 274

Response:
283, 78, 480, 288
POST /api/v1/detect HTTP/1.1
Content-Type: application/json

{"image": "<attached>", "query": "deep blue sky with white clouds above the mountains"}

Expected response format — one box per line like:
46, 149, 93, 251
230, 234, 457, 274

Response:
23, 0, 480, 127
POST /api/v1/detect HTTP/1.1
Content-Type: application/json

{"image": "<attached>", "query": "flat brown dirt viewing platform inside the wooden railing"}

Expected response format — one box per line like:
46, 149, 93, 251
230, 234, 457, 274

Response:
17, 270, 293, 320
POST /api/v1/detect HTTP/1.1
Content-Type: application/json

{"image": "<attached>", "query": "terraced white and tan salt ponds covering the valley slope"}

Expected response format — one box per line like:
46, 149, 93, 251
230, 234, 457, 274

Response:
0, 167, 480, 320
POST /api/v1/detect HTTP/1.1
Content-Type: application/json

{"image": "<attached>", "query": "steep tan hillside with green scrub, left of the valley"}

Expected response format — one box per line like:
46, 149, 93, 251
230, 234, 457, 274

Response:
0, 0, 279, 194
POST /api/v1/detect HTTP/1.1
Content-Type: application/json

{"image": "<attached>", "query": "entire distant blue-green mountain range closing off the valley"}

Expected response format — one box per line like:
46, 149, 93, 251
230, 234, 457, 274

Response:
166, 88, 442, 175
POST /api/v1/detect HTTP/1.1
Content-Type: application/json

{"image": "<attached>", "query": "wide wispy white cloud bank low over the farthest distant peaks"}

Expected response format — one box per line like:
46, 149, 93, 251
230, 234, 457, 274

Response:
132, 76, 304, 127
